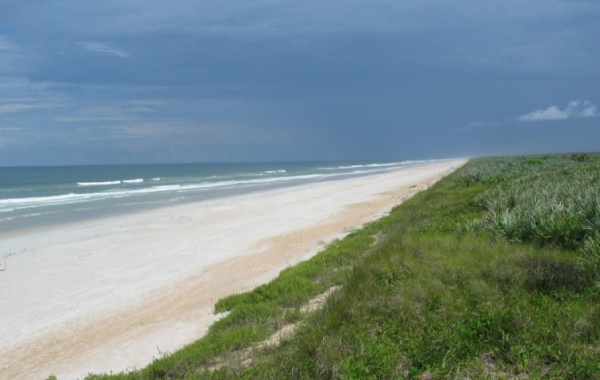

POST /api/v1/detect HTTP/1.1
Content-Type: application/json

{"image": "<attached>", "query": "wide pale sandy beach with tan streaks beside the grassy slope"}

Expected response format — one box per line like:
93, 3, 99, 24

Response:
0, 160, 465, 380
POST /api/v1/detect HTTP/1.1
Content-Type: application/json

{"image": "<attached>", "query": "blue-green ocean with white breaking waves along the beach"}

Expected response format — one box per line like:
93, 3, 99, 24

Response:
0, 160, 439, 236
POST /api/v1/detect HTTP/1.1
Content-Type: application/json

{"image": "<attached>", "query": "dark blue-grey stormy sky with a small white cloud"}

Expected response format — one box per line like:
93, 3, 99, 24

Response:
0, 0, 600, 166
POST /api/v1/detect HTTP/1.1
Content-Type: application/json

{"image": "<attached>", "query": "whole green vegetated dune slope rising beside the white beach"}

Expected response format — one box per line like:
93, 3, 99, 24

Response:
82, 154, 600, 379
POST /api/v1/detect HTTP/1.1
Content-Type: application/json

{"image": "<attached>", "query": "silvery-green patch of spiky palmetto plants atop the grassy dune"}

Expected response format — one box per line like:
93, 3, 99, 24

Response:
458, 155, 600, 249
